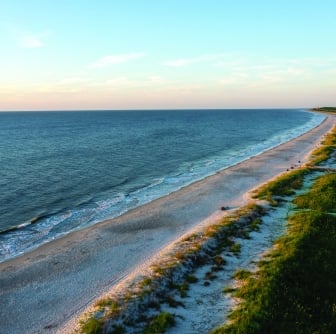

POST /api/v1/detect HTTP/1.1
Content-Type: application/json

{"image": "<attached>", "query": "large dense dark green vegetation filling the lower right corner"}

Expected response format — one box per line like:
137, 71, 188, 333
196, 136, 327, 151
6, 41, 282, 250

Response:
213, 174, 336, 334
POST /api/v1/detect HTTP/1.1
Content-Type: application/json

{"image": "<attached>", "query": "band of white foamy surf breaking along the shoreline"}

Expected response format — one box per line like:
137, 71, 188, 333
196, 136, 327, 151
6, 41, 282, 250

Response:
0, 113, 325, 262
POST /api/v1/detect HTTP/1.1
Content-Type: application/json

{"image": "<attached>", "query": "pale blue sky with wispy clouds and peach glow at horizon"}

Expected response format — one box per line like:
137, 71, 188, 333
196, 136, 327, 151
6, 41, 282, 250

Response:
0, 0, 336, 111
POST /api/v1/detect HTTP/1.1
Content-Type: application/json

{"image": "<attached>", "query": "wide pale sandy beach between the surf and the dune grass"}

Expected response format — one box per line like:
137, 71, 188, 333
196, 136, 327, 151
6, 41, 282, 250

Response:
0, 116, 335, 333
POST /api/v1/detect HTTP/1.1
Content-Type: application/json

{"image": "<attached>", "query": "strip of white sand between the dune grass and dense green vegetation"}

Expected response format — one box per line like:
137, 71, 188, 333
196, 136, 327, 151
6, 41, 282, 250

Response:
162, 208, 287, 334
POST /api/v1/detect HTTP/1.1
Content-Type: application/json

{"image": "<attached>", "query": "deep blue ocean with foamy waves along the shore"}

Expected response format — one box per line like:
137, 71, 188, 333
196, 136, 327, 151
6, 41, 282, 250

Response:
0, 109, 324, 262
